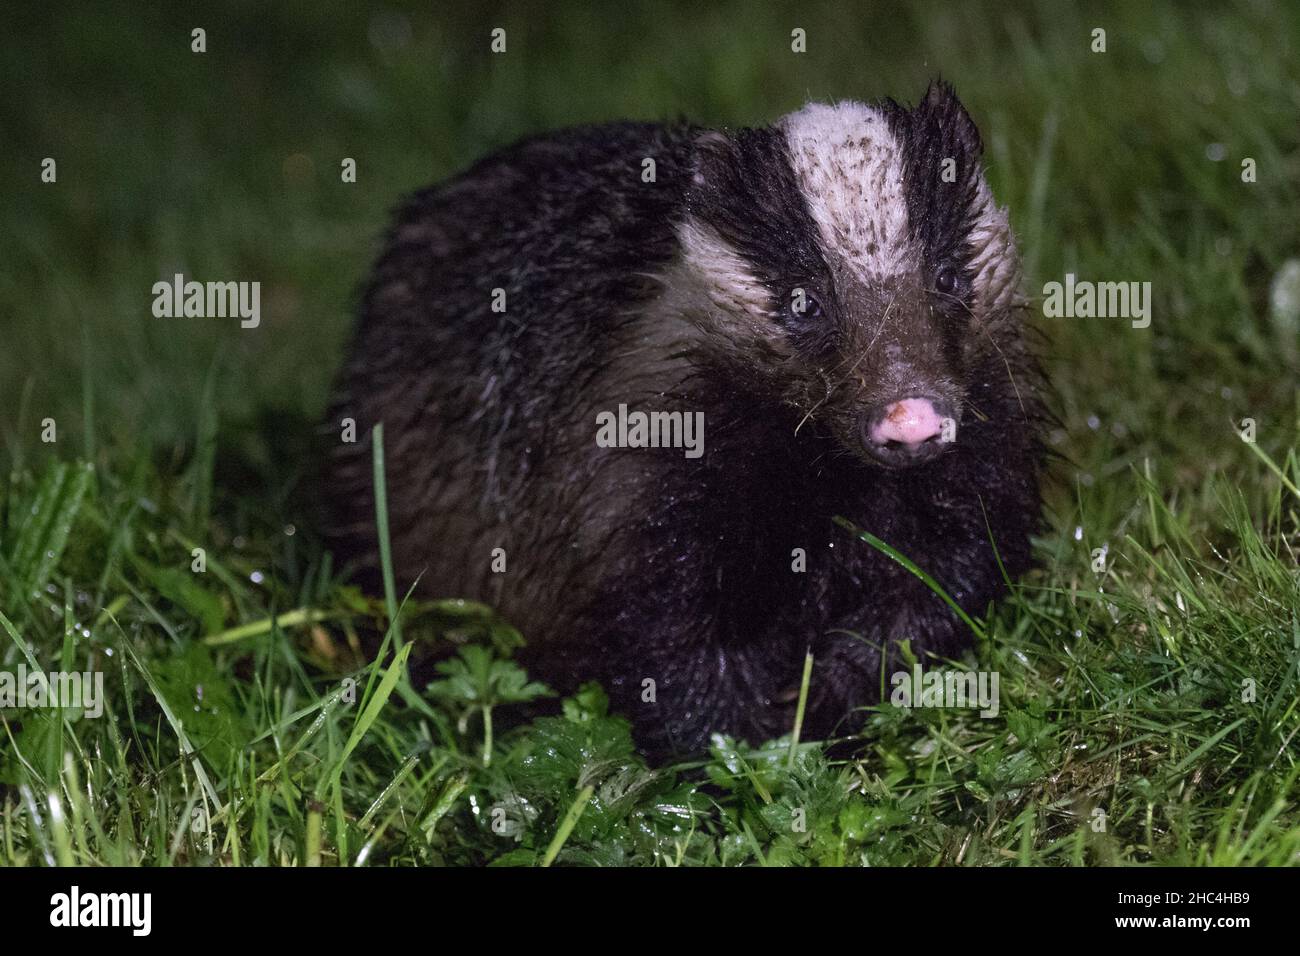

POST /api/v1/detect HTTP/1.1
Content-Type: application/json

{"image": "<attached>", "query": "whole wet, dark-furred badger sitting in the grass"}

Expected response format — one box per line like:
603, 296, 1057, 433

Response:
329, 85, 1041, 753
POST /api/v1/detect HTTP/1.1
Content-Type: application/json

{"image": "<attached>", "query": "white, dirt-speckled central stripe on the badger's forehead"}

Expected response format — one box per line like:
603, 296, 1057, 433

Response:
781, 101, 918, 282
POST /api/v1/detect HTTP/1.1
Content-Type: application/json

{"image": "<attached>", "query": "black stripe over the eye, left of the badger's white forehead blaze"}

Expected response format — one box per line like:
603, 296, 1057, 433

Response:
686, 127, 832, 304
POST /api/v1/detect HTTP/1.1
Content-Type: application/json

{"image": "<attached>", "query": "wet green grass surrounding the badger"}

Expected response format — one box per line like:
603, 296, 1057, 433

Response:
0, 3, 1300, 866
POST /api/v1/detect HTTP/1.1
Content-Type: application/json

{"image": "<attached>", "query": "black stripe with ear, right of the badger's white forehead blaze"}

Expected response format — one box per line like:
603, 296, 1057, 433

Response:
881, 83, 983, 298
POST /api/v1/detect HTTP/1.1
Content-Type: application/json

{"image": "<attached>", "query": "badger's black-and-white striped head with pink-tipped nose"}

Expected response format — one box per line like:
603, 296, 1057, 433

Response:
679, 85, 1019, 467
